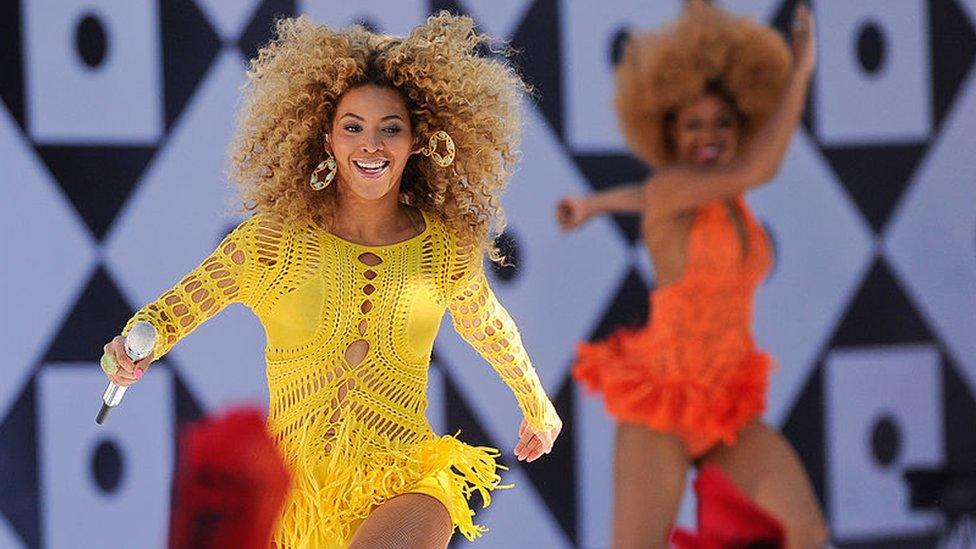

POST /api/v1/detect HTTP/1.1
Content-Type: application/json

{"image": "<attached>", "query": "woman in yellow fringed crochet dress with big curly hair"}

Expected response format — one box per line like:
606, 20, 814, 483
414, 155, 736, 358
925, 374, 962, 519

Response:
105, 14, 562, 547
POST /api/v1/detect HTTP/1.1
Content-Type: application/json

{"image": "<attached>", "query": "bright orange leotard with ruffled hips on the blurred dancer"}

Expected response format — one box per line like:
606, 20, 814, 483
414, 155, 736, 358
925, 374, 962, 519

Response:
573, 196, 772, 457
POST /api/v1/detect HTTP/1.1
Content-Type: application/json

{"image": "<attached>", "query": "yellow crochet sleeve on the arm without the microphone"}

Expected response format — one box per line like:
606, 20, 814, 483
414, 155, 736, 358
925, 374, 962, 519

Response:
449, 268, 560, 433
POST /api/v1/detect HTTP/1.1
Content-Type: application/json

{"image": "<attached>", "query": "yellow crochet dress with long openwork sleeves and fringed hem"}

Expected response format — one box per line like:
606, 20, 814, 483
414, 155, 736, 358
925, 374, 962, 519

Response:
123, 209, 559, 547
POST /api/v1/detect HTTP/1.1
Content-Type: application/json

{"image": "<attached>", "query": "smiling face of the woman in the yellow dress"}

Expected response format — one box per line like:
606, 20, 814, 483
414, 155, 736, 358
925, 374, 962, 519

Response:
327, 84, 414, 200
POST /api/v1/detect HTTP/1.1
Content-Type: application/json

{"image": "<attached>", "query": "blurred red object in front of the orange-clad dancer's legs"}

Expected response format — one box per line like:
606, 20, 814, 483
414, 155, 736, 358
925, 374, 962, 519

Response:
671, 465, 786, 549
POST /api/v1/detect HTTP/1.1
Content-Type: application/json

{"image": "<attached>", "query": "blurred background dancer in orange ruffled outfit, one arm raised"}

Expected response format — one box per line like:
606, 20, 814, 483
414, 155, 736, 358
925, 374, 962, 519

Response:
557, 2, 827, 547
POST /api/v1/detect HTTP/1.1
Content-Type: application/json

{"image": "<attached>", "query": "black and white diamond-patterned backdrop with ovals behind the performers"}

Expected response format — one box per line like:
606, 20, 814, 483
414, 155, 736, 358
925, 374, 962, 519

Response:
0, 0, 976, 548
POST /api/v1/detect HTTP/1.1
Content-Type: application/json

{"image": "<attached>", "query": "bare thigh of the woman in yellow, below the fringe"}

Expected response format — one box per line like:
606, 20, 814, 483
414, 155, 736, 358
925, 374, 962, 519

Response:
349, 494, 454, 549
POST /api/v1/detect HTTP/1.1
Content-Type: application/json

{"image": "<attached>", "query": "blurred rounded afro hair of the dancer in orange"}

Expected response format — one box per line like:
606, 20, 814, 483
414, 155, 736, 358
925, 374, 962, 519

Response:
614, 2, 793, 167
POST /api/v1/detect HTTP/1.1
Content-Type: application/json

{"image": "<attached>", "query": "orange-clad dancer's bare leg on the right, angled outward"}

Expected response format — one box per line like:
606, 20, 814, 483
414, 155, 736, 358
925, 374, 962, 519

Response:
702, 420, 829, 549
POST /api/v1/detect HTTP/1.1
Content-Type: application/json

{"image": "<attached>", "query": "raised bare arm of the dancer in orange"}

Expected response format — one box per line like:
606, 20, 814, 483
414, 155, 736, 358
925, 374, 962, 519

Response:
646, 4, 816, 214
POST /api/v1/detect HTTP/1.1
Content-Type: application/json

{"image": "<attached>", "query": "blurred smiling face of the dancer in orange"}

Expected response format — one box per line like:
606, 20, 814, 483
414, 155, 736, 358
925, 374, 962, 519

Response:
671, 93, 740, 165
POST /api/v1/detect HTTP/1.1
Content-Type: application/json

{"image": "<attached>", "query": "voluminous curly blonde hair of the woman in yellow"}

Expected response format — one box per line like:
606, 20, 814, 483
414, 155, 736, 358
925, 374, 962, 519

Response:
230, 12, 528, 253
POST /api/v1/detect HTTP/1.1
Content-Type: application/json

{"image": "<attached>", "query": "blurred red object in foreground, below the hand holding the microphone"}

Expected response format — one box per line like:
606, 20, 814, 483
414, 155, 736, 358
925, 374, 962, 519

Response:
169, 408, 291, 549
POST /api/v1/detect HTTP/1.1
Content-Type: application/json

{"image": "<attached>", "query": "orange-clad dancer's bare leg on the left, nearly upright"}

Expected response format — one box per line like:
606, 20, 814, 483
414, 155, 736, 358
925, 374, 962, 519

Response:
612, 423, 691, 549
